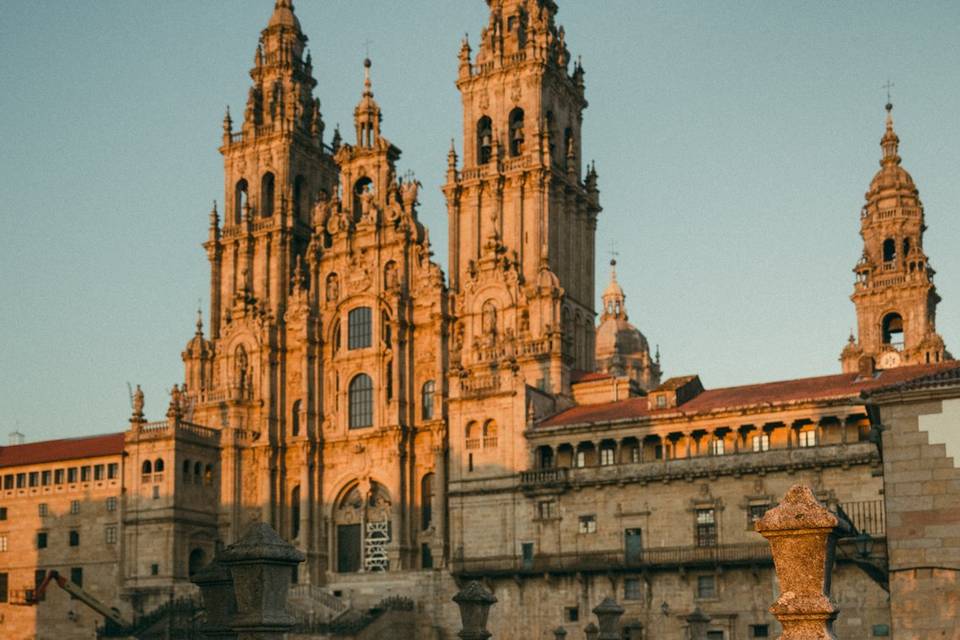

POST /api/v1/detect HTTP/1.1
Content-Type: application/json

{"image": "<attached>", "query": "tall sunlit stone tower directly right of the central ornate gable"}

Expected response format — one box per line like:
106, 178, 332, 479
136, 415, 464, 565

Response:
444, 0, 600, 484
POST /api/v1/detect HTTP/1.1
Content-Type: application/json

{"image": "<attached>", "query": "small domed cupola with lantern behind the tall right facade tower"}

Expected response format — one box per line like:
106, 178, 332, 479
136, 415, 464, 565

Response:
596, 260, 661, 391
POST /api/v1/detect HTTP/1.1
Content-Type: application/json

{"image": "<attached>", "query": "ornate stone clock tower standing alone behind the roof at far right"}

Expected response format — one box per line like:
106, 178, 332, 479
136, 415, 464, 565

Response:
840, 104, 950, 372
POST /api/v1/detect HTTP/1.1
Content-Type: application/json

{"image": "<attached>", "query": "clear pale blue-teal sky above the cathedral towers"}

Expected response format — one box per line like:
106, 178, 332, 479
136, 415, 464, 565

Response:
0, 0, 960, 440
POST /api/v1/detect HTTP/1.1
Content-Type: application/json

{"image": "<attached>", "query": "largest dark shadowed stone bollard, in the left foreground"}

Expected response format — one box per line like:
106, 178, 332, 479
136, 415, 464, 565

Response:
220, 523, 305, 640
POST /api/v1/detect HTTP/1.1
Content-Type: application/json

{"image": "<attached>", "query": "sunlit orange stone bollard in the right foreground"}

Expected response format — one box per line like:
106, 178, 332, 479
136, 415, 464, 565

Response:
757, 485, 840, 640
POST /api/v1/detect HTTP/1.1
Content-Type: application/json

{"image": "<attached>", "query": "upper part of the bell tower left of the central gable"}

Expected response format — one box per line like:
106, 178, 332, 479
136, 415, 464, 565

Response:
212, 0, 336, 330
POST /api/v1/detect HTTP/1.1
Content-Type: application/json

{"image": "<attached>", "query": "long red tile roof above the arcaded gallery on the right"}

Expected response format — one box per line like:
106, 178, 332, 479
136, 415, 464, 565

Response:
539, 362, 960, 427
